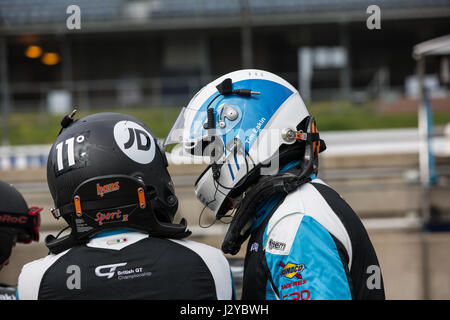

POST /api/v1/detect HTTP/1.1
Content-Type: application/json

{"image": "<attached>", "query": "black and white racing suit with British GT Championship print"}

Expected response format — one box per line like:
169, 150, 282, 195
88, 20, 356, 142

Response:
18, 232, 234, 300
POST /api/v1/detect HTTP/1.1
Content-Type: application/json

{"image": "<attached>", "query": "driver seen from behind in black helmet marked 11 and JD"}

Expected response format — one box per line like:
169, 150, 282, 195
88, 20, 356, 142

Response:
18, 113, 234, 300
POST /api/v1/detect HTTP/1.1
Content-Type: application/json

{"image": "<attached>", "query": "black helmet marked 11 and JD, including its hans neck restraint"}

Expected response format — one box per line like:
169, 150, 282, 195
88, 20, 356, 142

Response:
47, 113, 186, 251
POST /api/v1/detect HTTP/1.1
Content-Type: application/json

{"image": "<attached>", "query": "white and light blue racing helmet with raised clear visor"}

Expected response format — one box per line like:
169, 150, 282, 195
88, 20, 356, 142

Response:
164, 69, 320, 218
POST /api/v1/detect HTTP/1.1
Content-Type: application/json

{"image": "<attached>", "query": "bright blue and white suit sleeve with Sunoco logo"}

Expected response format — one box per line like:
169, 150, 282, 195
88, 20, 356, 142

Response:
263, 214, 352, 300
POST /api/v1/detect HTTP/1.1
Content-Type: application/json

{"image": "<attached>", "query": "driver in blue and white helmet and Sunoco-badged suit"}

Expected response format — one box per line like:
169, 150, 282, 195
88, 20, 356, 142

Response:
164, 69, 385, 300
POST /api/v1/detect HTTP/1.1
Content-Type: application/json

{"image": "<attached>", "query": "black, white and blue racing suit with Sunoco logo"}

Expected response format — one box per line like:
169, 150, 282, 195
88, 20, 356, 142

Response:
242, 179, 385, 300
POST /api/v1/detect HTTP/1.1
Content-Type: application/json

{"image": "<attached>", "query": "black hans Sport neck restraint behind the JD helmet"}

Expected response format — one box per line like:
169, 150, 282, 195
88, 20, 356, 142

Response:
45, 175, 191, 254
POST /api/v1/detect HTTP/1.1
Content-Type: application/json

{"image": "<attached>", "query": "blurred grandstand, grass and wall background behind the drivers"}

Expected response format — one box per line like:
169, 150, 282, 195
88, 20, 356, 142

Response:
0, 0, 450, 299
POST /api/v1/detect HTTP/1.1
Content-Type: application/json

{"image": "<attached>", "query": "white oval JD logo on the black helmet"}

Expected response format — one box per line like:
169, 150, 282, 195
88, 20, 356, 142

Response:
114, 121, 155, 164
